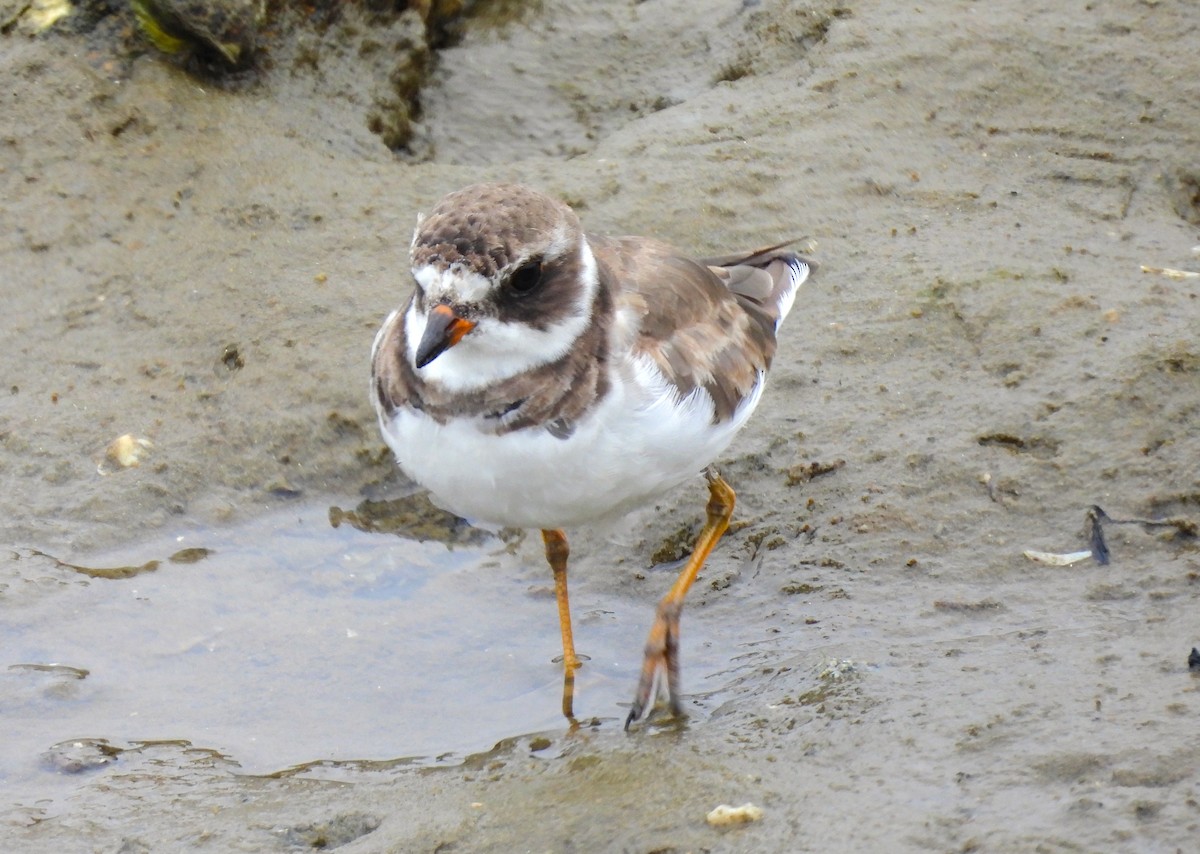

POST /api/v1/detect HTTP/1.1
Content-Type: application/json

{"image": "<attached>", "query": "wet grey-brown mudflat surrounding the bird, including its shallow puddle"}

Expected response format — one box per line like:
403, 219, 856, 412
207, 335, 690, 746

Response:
0, 0, 1200, 852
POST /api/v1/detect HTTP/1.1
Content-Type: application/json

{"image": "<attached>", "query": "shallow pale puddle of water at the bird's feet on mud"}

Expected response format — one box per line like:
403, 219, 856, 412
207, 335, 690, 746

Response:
0, 505, 736, 806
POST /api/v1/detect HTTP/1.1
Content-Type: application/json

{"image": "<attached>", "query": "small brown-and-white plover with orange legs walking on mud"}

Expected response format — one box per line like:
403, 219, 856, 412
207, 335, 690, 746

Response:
371, 184, 815, 730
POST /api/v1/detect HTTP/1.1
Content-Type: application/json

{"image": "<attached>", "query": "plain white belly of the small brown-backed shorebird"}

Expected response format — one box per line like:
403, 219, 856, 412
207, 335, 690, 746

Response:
380, 365, 762, 528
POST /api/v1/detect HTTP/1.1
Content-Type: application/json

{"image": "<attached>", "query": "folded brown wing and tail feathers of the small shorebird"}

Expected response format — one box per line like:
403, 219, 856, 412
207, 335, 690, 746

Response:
589, 236, 796, 422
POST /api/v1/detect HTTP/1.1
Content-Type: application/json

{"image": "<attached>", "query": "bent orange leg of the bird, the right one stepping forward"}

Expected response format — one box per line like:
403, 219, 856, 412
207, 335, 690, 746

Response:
625, 467, 734, 729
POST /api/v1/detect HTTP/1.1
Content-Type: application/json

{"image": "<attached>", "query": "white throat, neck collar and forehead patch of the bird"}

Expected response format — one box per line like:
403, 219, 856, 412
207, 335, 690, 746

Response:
404, 237, 600, 392
